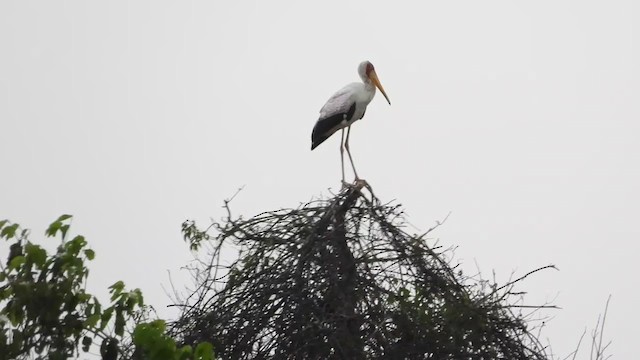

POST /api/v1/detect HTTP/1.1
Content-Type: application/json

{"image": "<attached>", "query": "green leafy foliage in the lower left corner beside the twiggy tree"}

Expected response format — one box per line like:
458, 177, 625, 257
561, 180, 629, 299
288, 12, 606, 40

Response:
0, 215, 213, 360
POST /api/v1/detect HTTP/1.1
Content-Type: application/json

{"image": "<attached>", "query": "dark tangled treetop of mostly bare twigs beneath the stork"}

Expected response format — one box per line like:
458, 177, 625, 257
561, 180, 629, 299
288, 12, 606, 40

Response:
172, 186, 553, 360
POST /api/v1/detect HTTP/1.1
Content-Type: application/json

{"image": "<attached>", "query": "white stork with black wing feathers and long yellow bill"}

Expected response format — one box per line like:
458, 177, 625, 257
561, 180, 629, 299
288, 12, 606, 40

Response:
311, 61, 391, 184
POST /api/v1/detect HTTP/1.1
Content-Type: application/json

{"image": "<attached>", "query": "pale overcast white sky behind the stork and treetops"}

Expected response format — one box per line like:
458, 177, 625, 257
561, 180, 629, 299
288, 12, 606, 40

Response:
0, 0, 640, 359
